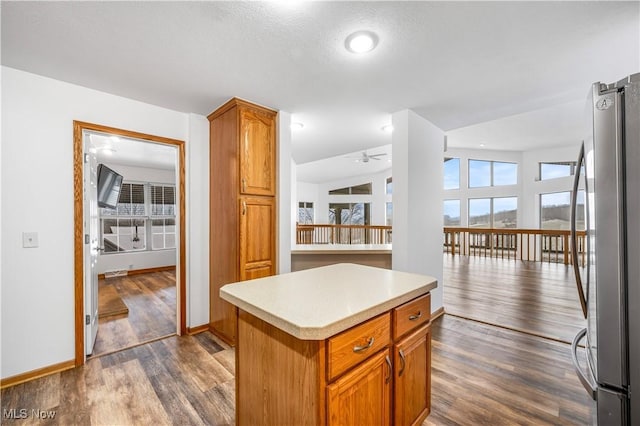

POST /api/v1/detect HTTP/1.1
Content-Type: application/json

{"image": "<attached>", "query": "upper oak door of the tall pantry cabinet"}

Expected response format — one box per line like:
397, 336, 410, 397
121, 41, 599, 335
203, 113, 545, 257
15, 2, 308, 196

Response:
239, 108, 276, 195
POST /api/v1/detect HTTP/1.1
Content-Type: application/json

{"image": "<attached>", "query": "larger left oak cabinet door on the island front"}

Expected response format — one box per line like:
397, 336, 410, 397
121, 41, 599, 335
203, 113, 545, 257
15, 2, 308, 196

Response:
327, 350, 392, 426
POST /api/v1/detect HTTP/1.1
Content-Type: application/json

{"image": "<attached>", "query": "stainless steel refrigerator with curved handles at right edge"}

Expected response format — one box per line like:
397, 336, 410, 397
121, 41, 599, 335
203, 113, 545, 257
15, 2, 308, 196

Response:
571, 73, 640, 426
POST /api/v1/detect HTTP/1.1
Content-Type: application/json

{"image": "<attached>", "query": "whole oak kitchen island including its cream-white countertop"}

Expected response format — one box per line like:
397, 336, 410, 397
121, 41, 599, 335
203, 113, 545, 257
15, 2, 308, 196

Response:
220, 264, 437, 425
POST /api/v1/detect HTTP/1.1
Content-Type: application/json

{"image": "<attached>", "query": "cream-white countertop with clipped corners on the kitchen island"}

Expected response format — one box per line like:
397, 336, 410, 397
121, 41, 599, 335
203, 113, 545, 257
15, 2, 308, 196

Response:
220, 263, 437, 340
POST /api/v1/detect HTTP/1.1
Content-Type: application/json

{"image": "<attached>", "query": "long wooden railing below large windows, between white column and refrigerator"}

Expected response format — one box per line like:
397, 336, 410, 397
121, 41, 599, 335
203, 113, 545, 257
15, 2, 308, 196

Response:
444, 227, 586, 266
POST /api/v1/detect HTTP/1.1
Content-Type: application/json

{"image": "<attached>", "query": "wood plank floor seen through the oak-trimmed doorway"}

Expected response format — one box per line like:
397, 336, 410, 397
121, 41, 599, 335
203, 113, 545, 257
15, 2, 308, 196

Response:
91, 271, 177, 356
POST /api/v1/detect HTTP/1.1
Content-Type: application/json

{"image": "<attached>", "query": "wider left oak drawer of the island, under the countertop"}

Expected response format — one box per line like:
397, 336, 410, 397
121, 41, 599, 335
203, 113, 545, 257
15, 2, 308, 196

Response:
327, 313, 391, 381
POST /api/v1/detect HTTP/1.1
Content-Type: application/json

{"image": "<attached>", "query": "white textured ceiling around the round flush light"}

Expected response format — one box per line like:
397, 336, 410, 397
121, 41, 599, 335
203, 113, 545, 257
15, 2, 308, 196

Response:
1, 1, 640, 179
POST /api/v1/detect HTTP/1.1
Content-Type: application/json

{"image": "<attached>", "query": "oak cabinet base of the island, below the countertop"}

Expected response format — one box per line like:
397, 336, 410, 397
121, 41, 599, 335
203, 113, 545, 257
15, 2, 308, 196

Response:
236, 294, 431, 426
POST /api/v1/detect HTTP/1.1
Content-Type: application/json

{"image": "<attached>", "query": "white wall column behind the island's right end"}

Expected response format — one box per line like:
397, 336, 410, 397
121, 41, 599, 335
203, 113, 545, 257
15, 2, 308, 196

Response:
392, 110, 444, 312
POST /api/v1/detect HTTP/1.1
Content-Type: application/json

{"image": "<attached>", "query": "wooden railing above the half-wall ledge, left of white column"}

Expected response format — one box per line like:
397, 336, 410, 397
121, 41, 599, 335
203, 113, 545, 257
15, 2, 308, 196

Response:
296, 224, 391, 244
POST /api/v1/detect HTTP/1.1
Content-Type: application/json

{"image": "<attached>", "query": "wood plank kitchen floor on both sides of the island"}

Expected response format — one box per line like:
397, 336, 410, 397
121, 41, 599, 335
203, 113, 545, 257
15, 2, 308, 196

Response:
1, 315, 593, 426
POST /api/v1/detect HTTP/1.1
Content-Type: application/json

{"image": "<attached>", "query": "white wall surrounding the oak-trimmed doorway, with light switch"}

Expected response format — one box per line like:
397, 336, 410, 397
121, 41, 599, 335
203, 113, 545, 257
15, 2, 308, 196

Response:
1, 67, 208, 378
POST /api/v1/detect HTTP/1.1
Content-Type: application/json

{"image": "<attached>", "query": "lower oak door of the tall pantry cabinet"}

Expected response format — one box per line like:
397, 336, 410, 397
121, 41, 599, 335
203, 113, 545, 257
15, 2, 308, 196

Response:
239, 197, 276, 281
